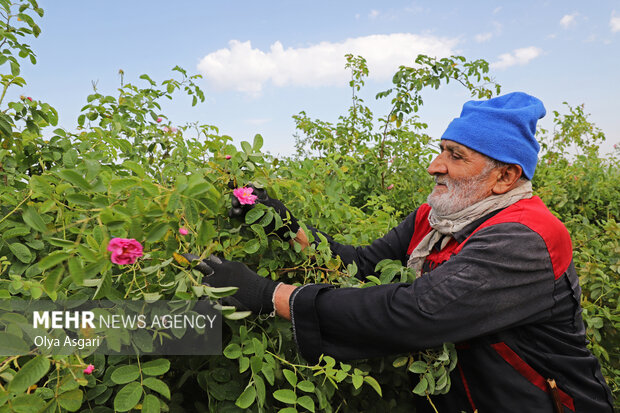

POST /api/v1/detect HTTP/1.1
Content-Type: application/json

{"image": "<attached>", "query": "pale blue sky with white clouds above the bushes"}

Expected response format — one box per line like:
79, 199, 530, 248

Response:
14, 0, 620, 155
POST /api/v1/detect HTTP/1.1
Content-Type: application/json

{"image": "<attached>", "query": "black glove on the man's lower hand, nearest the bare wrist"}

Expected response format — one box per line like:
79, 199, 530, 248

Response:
183, 254, 279, 314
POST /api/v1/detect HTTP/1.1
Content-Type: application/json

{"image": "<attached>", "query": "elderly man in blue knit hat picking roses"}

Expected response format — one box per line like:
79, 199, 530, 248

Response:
189, 93, 613, 413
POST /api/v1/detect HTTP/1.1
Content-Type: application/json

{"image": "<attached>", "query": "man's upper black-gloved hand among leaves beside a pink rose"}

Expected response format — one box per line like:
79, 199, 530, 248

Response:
228, 181, 299, 239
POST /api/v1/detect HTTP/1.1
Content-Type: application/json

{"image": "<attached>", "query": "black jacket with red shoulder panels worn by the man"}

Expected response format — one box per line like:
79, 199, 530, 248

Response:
291, 197, 613, 413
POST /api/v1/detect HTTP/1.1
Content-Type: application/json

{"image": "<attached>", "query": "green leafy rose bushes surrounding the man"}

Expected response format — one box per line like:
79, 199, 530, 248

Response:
0, 0, 620, 412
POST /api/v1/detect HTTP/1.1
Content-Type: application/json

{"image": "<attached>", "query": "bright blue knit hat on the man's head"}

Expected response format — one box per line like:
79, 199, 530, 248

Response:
441, 92, 546, 179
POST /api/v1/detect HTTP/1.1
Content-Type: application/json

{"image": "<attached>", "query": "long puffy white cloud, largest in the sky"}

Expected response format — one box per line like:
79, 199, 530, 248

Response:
198, 33, 458, 95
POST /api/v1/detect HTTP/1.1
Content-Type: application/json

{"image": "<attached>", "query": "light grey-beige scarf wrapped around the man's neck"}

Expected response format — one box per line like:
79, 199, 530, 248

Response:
407, 181, 532, 277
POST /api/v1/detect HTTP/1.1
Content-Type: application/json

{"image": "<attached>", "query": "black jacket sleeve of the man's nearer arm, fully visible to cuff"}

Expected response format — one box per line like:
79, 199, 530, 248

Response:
290, 223, 555, 362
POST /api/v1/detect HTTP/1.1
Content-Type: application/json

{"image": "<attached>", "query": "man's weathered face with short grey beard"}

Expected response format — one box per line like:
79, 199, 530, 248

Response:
428, 140, 496, 215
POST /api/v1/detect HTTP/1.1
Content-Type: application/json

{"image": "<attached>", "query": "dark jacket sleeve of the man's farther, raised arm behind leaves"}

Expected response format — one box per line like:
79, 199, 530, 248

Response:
308, 211, 416, 279
